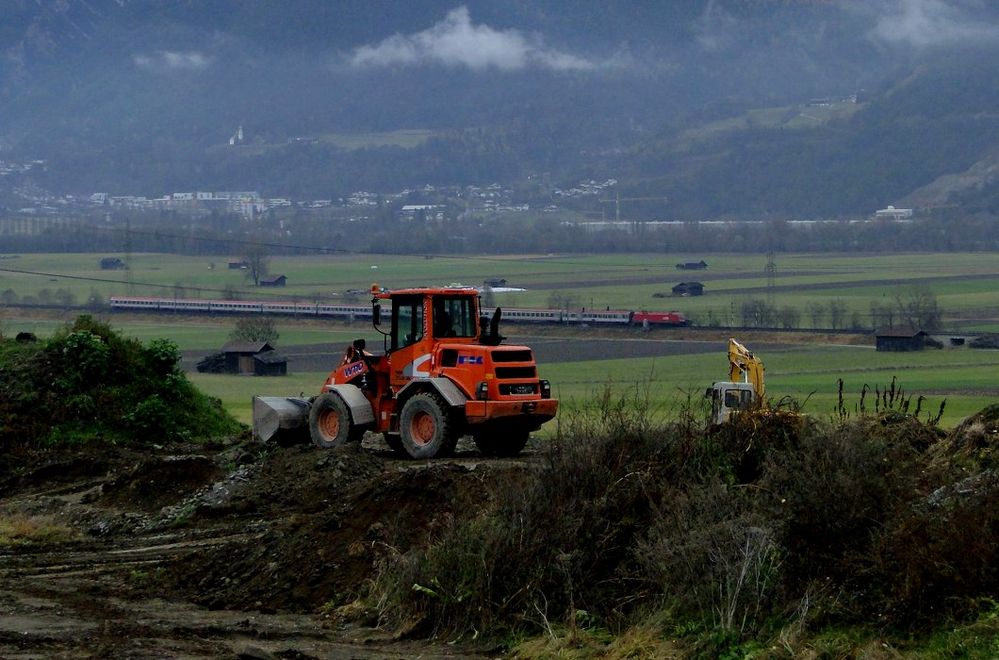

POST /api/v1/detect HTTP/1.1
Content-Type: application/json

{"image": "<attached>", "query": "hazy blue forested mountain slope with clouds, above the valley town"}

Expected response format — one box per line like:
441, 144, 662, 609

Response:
0, 0, 999, 217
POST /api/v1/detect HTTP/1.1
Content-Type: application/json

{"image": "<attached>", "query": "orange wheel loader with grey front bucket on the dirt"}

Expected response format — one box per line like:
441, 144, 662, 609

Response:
253, 285, 558, 458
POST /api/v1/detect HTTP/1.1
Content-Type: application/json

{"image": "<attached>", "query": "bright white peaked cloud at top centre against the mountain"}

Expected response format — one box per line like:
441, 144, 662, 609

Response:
349, 7, 598, 71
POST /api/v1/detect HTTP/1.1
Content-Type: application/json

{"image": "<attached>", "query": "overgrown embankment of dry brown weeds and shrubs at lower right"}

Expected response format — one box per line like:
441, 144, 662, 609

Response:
364, 396, 999, 658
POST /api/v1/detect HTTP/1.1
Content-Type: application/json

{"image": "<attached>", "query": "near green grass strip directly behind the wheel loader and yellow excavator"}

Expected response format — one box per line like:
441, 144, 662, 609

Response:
191, 346, 999, 427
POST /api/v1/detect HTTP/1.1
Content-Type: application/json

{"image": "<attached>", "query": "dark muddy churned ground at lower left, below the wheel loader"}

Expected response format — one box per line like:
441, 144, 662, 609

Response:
0, 434, 538, 658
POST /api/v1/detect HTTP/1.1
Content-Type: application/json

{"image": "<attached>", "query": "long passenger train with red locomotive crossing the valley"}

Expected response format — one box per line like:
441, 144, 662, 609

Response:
110, 296, 687, 327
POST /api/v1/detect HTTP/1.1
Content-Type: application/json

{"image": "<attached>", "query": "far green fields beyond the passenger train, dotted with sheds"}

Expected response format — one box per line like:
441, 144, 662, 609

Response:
0, 253, 999, 332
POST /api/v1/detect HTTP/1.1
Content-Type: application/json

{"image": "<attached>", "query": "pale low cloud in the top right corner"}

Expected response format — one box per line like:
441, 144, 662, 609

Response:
870, 0, 999, 48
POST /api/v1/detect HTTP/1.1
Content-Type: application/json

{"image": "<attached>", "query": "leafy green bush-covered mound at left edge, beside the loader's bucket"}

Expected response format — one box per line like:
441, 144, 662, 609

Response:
0, 316, 240, 447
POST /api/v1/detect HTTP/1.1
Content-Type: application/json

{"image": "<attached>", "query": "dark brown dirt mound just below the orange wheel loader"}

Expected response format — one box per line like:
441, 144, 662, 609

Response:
167, 445, 516, 612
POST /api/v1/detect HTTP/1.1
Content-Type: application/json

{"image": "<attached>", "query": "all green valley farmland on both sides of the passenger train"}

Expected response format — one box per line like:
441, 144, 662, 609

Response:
0, 253, 999, 424
